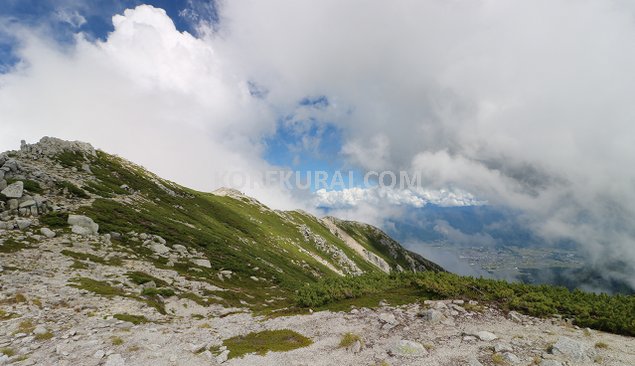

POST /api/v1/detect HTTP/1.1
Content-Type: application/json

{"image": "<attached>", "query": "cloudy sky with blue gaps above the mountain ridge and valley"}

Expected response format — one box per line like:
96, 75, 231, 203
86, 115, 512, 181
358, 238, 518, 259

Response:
0, 0, 635, 287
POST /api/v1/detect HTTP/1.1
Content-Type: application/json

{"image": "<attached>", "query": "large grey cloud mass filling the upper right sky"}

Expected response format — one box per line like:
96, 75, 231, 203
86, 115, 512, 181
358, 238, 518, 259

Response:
212, 0, 635, 286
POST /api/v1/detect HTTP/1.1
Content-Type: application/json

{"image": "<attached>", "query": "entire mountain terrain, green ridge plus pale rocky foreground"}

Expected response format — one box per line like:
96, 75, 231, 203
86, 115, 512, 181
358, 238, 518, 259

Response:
0, 137, 635, 366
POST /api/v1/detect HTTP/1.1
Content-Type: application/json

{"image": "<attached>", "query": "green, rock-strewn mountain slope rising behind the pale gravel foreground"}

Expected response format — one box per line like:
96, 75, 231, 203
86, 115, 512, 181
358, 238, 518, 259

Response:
2, 138, 442, 307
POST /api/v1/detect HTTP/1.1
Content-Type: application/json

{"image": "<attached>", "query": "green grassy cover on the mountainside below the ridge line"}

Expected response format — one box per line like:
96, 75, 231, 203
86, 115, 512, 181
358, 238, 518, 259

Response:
58, 152, 432, 307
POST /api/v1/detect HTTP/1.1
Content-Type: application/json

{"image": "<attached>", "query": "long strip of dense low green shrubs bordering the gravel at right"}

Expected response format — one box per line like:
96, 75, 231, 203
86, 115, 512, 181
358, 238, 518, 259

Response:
296, 272, 635, 336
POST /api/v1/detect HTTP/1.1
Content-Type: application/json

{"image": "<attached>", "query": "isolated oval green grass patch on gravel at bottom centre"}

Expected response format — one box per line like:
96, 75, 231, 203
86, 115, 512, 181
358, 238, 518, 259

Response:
223, 329, 313, 358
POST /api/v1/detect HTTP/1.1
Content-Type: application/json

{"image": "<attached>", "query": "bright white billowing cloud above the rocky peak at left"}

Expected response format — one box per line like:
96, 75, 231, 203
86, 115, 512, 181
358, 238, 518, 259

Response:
0, 5, 301, 212
